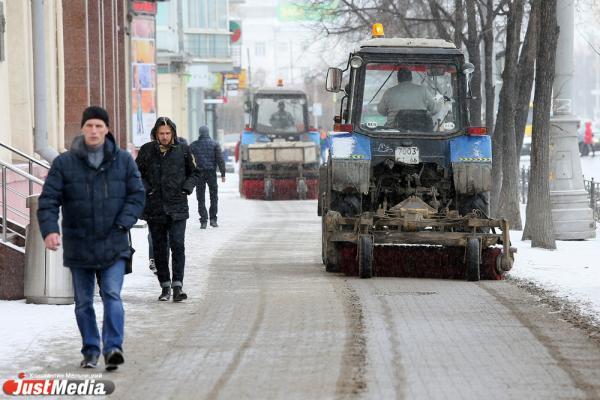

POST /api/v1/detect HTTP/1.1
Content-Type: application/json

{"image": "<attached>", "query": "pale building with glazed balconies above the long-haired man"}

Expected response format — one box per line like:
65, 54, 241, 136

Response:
157, 0, 233, 140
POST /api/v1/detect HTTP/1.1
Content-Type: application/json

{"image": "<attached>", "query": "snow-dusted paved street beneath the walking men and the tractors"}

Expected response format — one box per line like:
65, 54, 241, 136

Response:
0, 176, 600, 399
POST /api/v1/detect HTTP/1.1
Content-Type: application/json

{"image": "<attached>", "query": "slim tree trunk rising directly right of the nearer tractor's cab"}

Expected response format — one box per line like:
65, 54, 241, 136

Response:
465, 0, 481, 126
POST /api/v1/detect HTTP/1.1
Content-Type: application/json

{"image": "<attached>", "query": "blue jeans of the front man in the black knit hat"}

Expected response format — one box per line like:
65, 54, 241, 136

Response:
70, 259, 125, 355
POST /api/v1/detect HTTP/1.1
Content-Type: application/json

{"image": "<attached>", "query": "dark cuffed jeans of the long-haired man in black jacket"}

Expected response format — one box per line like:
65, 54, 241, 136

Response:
148, 218, 186, 287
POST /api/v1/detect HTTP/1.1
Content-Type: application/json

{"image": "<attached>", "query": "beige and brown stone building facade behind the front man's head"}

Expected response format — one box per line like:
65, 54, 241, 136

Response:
0, 0, 130, 162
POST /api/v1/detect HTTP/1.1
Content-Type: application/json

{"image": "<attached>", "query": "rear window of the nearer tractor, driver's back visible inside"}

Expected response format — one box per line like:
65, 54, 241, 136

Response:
360, 63, 459, 134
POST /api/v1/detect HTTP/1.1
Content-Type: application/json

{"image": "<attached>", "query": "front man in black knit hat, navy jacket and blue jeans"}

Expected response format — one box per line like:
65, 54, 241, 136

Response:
37, 106, 144, 371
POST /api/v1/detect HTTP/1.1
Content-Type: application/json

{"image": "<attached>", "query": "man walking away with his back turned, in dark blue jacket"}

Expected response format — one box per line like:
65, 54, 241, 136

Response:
190, 126, 225, 229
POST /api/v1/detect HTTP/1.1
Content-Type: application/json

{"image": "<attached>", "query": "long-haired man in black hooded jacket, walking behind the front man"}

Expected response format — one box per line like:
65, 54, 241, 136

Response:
136, 117, 197, 301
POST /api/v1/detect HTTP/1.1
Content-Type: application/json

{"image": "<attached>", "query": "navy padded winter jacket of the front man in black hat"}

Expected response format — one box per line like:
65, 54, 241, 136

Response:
37, 133, 145, 269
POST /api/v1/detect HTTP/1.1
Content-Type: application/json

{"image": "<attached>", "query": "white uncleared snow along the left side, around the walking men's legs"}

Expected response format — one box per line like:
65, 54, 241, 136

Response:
0, 175, 257, 380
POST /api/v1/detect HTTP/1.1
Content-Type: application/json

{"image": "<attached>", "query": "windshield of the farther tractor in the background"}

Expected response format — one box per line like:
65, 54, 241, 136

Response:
254, 96, 307, 134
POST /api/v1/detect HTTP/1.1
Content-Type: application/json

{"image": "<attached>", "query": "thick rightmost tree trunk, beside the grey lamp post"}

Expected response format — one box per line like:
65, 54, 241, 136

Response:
523, 0, 558, 249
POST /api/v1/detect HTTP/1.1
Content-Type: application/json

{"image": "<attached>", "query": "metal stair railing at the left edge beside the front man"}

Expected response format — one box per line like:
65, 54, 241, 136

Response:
0, 142, 50, 243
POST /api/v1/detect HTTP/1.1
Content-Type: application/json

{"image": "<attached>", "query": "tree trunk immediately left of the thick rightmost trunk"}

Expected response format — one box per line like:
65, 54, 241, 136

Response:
497, 0, 525, 230
